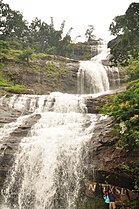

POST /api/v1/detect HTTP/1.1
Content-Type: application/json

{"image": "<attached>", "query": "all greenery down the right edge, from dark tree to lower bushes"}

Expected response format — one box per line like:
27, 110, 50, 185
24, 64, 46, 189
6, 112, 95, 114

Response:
102, 3, 139, 191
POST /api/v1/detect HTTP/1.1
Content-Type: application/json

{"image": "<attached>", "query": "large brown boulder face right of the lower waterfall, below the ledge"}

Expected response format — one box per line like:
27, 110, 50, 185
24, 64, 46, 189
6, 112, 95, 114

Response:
86, 116, 135, 189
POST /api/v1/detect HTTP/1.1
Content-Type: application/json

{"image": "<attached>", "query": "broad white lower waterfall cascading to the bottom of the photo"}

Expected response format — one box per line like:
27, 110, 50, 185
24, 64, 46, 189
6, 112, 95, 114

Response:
0, 92, 102, 209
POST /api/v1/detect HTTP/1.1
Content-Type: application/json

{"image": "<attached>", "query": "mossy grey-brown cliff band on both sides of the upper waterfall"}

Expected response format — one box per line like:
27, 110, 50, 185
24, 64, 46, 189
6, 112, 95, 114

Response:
0, 56, 126, 94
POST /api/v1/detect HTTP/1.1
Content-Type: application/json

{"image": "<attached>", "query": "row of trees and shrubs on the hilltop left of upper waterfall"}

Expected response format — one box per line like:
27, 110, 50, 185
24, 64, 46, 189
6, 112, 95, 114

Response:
0, 0, 98, 61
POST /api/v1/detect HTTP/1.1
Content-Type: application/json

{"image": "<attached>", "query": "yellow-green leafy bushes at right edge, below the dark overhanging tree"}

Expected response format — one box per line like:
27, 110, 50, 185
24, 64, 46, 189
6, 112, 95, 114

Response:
101, 79, 139, 191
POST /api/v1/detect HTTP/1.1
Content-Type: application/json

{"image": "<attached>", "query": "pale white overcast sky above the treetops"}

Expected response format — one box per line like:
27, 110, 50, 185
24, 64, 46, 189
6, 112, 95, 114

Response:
3, 0, 139, 41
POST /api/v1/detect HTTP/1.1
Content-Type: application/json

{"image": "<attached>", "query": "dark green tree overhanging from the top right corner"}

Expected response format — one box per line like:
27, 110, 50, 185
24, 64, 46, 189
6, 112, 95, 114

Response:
108, 3, 139, 65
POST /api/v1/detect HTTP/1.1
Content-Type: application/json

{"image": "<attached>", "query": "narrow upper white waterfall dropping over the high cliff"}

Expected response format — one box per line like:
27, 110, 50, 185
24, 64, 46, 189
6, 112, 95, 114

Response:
77, 43, 120, 94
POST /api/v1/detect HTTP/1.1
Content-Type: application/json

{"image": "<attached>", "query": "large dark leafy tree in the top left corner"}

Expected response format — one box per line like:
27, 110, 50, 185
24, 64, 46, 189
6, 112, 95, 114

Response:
0, 1, 28, 49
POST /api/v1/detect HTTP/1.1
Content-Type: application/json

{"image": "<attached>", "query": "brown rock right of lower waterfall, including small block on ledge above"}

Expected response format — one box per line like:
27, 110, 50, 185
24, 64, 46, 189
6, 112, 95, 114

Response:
82, 92, 139, 189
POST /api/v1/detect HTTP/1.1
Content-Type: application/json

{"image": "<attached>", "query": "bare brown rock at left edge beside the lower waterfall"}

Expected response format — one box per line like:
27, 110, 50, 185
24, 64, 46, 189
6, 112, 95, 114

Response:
0, 103, 40, 188
